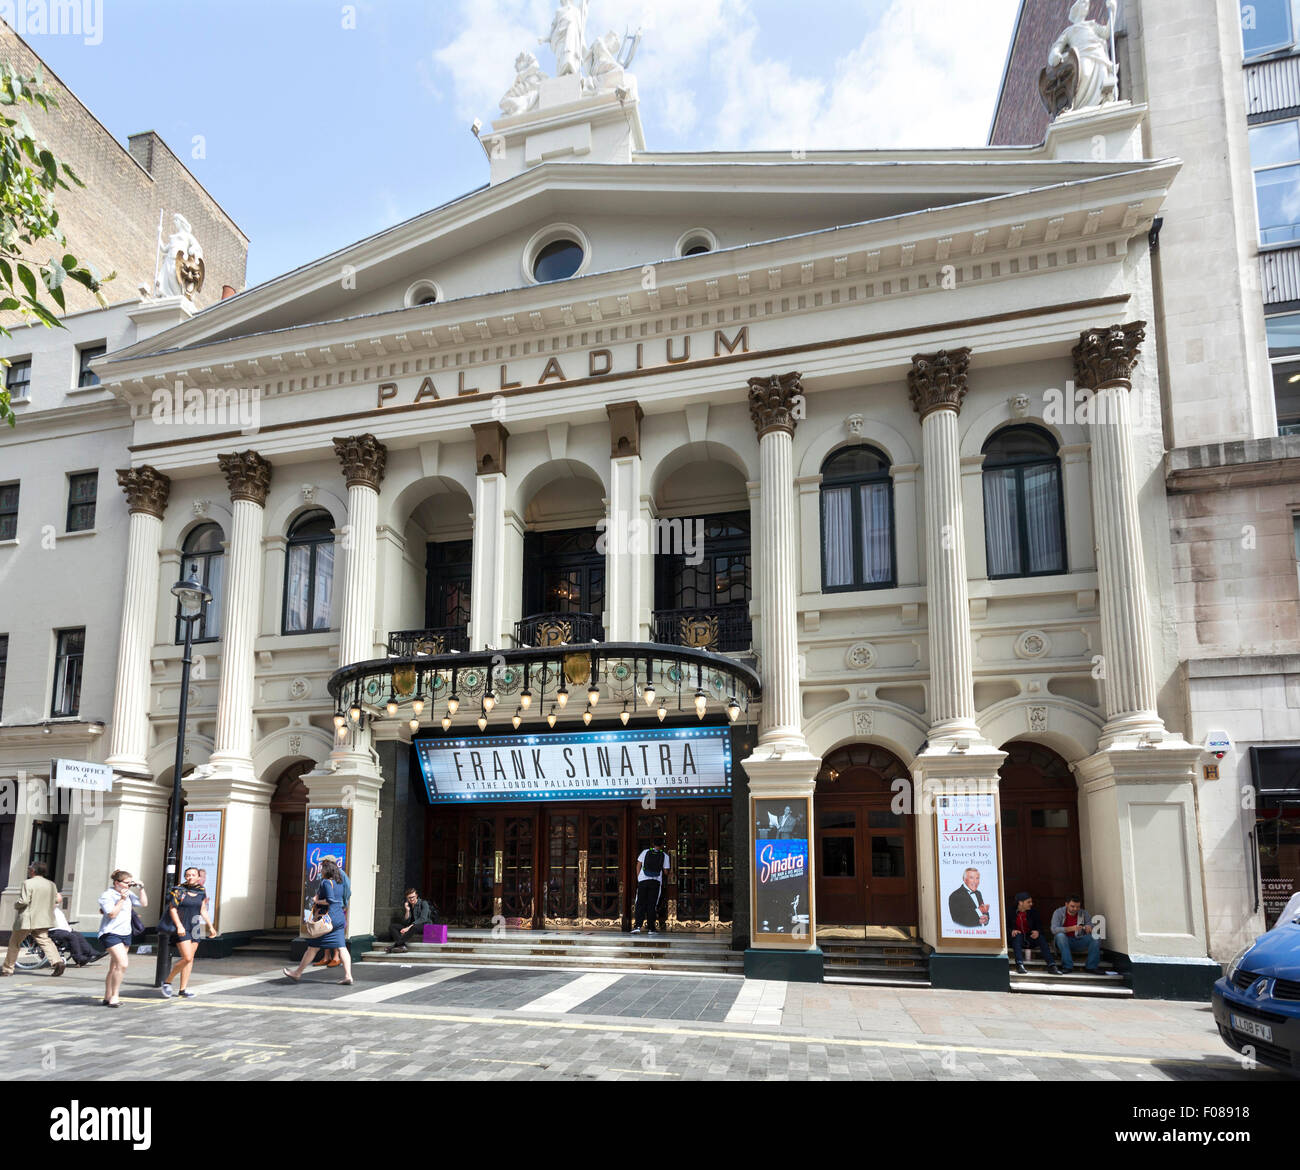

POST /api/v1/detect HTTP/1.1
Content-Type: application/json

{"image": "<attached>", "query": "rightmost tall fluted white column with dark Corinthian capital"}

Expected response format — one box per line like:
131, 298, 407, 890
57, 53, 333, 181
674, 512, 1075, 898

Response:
1074, 321, 1164, 746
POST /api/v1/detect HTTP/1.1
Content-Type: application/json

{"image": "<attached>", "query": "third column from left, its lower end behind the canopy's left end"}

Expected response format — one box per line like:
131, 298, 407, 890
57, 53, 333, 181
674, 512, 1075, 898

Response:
334, 434, 389, 666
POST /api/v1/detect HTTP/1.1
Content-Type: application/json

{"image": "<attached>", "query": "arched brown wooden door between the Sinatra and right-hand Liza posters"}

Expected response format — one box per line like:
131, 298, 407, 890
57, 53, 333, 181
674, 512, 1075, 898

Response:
814, 744, 918, 935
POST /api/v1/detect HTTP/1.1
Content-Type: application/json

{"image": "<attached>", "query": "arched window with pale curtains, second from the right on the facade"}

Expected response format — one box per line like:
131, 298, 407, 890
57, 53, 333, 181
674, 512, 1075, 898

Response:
822, 446, 894, 593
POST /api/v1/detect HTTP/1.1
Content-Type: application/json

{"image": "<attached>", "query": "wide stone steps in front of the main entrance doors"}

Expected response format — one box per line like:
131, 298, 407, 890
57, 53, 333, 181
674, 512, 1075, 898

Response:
361, 930, 745, 975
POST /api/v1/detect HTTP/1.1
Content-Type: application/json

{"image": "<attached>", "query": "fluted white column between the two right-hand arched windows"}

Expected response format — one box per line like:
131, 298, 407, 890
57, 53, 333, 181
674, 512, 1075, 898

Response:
907, 348, 979, 740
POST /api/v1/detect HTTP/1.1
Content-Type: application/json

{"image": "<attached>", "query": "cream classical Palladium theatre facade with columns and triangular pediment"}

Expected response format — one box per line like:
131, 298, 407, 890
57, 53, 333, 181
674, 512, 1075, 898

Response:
78, 27, 1217, 985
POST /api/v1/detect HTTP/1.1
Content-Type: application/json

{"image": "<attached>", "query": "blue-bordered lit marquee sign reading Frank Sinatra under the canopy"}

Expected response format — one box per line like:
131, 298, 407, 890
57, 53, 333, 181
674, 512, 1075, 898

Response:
415, 727, 732, 805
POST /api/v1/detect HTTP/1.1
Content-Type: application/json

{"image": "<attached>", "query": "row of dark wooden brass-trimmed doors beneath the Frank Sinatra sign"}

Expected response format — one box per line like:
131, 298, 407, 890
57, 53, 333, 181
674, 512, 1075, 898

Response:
425, 802, 733, 931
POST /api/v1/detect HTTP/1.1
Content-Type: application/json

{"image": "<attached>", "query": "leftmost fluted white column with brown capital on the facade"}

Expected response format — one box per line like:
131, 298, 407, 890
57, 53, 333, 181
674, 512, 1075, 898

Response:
108, 467, 172, 774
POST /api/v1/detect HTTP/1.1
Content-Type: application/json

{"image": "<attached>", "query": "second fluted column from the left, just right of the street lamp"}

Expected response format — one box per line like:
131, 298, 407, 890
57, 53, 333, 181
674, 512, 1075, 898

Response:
211, 451, 270, 779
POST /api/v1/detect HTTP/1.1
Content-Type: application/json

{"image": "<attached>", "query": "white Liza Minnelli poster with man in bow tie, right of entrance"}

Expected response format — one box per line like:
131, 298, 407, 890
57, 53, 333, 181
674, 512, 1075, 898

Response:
935, 793, 1002, 943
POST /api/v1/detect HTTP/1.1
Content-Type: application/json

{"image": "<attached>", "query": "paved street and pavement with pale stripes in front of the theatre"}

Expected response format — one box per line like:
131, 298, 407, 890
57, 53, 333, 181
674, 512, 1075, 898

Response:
0, 956, 1294, 1083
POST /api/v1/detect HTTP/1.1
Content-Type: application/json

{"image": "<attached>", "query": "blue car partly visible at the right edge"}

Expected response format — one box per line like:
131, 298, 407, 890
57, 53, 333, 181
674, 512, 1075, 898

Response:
1213, 917, 1300, 1076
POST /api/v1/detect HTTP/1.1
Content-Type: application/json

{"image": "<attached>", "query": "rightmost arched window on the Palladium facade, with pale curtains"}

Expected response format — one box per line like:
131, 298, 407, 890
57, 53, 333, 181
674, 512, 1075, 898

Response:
984, 426, 1066, 577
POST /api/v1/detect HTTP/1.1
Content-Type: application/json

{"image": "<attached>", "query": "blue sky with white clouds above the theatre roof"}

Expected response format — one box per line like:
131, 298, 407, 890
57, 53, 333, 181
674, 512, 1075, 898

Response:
18, 0, 1018, 286
